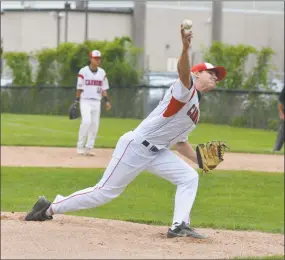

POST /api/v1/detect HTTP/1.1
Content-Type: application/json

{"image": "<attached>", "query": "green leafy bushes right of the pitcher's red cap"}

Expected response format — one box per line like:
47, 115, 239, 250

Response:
202, 42, 274, 89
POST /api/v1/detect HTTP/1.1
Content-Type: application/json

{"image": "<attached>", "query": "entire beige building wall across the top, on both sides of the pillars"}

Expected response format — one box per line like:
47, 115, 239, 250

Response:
1, 6, 284, 71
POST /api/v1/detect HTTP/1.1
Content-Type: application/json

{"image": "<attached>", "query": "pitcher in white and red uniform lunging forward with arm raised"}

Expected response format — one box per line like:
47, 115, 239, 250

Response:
25, 23, 229, 239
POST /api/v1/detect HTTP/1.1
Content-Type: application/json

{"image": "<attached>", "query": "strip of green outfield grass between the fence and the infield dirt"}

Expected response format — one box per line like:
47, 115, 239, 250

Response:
1, 114, 284, 153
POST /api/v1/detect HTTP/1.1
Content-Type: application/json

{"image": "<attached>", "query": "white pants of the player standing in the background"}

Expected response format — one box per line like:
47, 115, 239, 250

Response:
77, 99, 101, 152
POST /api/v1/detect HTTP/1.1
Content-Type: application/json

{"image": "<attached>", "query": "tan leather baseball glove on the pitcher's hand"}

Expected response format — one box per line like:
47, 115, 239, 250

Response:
196, 141, 229, 173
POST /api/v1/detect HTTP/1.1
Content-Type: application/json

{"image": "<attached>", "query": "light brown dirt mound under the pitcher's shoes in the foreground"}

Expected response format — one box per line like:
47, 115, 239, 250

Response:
1, 212, 284, 259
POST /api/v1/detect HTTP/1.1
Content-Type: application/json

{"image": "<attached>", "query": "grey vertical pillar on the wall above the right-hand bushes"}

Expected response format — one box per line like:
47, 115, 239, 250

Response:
212, 0, 223, 42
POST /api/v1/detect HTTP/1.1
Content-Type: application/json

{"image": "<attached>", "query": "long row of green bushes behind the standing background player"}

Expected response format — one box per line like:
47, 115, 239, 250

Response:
5, 37, 141, 87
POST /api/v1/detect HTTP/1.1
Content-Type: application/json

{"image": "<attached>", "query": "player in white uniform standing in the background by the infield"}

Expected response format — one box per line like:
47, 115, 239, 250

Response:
75, 50, 111, 156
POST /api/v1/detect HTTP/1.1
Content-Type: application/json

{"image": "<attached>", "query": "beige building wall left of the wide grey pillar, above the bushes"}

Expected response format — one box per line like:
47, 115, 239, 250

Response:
1, 11, 132, 51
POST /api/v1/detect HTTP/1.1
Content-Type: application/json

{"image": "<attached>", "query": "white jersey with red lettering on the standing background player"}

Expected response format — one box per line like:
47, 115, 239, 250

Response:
76, 66, 109, 100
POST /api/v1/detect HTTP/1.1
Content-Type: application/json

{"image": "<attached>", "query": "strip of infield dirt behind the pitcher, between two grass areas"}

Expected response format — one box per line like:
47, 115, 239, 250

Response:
1, 146, 284, 172
